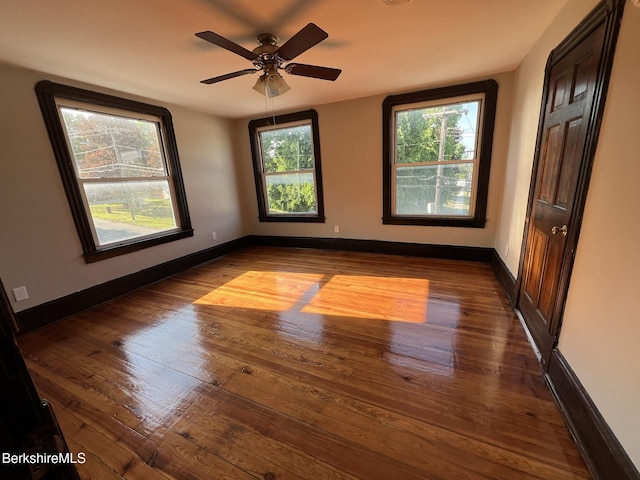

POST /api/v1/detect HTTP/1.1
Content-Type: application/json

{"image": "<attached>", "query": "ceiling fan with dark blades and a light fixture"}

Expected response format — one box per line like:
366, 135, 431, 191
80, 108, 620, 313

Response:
196, 23, 342, 97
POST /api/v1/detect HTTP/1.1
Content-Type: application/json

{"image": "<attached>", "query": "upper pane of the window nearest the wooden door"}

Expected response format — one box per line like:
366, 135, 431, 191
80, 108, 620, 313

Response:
396, 101, 480, 163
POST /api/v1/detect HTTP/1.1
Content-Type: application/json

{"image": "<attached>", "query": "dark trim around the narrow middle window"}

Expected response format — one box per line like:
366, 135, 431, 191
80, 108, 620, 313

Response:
249, 110, 325, 223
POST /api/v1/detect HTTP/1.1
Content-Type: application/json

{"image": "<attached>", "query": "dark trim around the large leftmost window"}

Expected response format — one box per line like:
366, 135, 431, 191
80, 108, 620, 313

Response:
36, 80, 193, 263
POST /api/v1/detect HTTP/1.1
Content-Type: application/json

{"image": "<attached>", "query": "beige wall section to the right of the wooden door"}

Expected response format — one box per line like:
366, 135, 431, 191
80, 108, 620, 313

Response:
559, 4, 640, 469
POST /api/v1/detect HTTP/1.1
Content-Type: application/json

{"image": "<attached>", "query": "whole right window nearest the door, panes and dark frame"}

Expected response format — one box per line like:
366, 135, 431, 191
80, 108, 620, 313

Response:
383, 80, 498, 228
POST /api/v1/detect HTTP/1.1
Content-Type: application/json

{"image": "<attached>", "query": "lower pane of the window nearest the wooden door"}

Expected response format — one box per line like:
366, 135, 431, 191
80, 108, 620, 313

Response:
395, 163, 473, 216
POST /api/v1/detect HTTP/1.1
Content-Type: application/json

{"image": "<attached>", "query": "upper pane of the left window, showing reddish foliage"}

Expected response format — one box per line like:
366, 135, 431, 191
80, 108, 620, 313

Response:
60, 107, 166, 178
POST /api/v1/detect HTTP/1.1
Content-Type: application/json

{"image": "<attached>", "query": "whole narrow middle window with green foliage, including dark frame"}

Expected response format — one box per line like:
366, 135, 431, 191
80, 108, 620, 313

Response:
249, 110, 325, 222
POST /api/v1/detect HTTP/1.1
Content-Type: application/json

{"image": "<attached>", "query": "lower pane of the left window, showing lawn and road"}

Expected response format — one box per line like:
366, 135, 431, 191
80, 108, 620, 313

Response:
84, 180, 177, 245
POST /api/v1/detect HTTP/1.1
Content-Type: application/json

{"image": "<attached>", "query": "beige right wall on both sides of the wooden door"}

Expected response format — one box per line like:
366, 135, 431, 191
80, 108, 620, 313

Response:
495, 0, 640, 468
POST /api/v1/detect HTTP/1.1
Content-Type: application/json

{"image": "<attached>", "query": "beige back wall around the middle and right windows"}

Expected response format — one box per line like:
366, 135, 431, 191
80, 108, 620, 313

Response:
237, 73, 513, 251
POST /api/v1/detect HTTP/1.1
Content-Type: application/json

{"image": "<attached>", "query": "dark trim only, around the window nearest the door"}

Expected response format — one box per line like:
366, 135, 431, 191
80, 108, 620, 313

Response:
382, 79, 498, 228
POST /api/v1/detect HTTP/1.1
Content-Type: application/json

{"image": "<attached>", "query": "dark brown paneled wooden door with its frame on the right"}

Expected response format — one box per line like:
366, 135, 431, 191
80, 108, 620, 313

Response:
518, 2, 622, 366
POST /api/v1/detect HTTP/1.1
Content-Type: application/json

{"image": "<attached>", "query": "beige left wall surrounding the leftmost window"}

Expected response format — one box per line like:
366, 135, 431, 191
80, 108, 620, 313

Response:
0, 65, 246, 311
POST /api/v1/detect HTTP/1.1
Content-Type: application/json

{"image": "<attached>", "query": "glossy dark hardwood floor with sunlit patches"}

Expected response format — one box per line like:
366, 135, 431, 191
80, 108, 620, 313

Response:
19, 247, 591, 480
